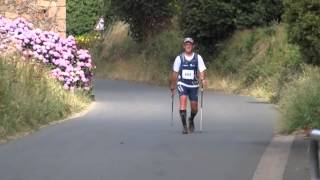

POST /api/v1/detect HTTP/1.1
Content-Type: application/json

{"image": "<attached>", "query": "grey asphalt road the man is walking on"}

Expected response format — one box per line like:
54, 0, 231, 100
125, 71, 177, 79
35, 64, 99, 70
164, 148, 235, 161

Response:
0, 80, 277, 180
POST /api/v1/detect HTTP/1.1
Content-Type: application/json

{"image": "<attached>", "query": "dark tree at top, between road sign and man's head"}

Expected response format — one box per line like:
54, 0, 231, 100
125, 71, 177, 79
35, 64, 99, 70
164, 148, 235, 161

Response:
111, 0, 175, 41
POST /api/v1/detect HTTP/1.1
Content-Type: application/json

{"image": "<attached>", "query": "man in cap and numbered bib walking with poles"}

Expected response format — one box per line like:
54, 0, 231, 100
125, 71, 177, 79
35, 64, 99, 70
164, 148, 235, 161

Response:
170, 37, 206, 134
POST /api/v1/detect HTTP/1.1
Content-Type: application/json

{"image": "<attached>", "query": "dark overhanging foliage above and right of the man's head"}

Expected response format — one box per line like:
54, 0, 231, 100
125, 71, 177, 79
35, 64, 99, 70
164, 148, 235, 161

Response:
180, 0, 282, 52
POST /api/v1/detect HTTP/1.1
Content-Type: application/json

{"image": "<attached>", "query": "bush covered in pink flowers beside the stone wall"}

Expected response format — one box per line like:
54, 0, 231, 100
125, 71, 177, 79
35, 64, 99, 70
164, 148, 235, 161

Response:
0, 16, 94, 90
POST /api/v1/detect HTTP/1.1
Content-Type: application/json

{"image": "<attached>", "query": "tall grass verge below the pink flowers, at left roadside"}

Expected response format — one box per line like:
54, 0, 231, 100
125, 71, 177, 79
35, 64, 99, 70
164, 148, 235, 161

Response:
0, 54, 90, 139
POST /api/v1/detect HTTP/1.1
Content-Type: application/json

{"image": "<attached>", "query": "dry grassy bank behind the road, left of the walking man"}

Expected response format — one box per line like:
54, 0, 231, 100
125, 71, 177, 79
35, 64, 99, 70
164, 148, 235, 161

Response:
93, 22, 182, 85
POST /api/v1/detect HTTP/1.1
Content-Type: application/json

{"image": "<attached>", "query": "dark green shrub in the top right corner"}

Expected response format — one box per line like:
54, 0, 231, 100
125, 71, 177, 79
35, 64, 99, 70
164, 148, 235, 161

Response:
284, 0, 320, 65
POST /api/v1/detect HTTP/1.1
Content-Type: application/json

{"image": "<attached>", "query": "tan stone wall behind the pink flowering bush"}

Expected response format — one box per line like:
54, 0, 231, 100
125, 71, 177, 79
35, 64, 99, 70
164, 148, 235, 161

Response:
0, 0, 66, 36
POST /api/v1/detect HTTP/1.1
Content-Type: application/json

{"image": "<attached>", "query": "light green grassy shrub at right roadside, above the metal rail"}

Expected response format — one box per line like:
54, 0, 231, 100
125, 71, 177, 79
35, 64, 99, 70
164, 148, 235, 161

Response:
280, 68, 320, 133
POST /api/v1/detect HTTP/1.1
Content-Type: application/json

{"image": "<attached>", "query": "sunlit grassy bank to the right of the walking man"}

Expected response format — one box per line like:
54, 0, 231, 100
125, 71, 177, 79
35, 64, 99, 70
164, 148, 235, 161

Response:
208, 25, 303, 100
